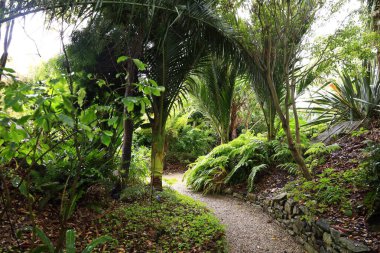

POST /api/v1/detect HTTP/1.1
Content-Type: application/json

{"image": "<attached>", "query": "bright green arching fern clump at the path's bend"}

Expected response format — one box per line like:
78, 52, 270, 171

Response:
185, 132, 270, 193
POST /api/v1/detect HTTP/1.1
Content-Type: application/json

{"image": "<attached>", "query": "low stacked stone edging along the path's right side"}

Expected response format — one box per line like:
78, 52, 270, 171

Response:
225, 189, 373, 253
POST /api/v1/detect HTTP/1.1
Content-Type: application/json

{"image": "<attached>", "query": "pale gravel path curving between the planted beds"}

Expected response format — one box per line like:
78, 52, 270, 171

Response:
164, 173, 304, 253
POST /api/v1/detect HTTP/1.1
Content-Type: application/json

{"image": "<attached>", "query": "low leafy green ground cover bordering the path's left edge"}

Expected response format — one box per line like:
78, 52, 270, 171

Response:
99, 189, 226, 252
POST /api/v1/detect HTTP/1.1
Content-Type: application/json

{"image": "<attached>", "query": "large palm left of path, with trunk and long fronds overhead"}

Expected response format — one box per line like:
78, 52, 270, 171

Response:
0, 0, 240, 189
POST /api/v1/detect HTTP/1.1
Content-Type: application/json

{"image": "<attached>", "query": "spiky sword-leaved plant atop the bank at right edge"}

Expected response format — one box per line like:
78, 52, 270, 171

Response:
310, 66, 380, 124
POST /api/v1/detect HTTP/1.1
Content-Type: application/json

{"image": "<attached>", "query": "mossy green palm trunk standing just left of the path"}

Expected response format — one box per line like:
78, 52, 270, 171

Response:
151, 117, 165, 191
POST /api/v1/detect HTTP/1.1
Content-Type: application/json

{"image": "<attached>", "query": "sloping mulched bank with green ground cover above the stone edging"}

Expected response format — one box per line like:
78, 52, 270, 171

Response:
285, 127, 380, 251
